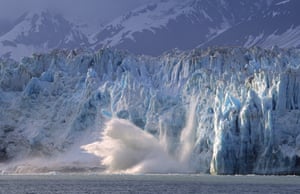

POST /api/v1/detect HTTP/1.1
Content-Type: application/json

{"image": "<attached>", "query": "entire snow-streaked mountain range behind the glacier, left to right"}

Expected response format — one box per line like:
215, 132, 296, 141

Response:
0, 0, 300, 59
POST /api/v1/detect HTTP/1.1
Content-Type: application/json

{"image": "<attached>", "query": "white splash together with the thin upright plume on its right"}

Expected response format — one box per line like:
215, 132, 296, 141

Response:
82, 97, 198, 173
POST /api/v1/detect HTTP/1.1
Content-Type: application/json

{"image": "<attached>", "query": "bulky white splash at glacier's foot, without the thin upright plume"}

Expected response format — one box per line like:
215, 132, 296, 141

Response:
82, 118, 186, 173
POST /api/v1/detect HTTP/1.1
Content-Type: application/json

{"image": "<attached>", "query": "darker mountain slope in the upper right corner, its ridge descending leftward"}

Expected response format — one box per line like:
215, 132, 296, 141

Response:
202, 0, 300, 48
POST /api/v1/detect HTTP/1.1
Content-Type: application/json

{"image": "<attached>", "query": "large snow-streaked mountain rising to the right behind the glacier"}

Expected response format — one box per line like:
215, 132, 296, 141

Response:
96, 0, 300, 55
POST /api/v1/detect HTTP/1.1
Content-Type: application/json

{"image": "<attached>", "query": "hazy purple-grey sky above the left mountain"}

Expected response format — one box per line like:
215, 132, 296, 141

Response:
0, 0, 154, 21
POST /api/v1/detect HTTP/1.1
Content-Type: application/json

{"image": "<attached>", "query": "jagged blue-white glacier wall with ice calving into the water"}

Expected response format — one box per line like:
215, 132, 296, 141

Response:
0, 47, 300, 175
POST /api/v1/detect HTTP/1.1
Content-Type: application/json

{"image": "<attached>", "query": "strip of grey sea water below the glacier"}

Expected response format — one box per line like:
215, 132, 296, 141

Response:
0, 174, 300, 194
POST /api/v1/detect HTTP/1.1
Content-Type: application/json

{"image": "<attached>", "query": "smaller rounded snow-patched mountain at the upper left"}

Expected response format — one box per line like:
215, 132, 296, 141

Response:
0, 10, 89, 59
